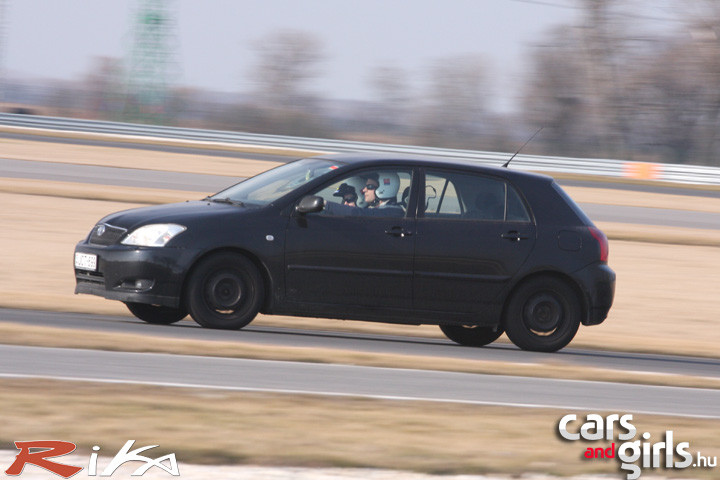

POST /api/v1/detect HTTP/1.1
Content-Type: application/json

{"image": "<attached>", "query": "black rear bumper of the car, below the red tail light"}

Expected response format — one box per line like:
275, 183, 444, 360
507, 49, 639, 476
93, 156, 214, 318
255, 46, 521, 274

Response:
574, 263, 615, 325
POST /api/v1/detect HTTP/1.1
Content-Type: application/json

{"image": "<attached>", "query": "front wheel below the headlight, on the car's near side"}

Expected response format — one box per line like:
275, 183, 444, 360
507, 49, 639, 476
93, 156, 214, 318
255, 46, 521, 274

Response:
186, 253, 264, 330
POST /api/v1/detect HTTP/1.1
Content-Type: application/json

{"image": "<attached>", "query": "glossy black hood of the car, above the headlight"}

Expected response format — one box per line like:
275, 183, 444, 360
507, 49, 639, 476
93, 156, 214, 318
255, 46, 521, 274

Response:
98, 201, 257, 231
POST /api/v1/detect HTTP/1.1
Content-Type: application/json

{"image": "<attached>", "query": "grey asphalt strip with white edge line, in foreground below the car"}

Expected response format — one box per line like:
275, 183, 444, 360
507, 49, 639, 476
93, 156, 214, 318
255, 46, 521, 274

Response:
0, 345, 720, 418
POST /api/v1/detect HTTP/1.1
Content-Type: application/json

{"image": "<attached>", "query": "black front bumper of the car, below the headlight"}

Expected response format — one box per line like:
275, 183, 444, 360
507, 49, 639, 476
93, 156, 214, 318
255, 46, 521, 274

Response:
75, 242, 196, 308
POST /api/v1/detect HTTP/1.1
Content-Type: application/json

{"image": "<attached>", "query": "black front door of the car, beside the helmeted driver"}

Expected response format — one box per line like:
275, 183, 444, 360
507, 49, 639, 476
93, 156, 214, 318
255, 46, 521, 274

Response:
285, 169, 415, 309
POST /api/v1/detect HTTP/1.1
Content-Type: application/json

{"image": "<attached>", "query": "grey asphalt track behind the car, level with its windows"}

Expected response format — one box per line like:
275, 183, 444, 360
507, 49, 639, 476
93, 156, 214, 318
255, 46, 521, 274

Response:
0, 155, 720, 230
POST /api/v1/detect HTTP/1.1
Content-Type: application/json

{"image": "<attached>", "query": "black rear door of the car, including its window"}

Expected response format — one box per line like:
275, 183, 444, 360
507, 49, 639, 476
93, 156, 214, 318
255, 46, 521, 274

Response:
414, 170, 535, 313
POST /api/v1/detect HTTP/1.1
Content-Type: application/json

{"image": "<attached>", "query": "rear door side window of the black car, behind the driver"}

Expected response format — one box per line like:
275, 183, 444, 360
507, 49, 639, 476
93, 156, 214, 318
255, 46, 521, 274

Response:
424, 171, 530, 222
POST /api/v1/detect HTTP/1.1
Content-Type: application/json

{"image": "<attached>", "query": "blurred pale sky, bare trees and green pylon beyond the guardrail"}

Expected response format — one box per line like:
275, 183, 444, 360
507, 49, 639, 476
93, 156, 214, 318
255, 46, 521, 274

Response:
0, 0, 720, 165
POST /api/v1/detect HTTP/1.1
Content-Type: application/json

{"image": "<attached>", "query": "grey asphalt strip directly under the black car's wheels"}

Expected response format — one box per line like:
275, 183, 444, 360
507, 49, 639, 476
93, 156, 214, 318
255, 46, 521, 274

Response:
0, 309, 720, 378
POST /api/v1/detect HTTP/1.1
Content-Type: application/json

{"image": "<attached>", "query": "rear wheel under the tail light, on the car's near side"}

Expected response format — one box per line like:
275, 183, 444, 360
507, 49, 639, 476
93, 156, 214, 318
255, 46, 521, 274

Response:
504, 277, 582, 352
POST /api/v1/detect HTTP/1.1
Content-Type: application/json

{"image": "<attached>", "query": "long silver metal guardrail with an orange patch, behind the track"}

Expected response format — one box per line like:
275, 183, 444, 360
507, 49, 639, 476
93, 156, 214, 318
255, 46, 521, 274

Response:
0, 113, 720, 185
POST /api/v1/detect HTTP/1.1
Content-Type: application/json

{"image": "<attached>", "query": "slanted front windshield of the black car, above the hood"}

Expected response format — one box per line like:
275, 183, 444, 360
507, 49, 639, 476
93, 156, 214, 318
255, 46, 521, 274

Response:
209, 158, 338, 206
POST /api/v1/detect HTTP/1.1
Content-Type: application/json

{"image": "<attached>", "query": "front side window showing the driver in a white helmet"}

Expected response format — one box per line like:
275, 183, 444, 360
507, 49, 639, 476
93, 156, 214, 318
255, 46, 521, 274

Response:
313, 168, 412, 217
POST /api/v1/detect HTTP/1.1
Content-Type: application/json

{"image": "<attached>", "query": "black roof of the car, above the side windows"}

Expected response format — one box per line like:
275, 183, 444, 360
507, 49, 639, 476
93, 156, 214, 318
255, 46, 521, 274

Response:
320, 153, 553, 185
